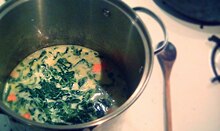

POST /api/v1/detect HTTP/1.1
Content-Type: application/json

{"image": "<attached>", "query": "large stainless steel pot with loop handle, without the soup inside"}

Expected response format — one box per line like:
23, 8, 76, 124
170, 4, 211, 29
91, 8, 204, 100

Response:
0, 0, 167, 130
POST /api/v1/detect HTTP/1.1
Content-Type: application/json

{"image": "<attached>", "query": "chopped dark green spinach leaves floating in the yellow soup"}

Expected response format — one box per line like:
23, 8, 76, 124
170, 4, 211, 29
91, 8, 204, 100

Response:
4, 46, 119, 125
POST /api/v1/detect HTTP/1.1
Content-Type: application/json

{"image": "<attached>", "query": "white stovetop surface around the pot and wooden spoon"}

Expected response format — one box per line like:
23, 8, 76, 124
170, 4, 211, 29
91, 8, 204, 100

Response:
0, 0, 220, 131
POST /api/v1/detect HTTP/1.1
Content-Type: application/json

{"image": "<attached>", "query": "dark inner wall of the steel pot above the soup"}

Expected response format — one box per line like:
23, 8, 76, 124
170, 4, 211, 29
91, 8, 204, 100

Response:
0, 0, 150, 104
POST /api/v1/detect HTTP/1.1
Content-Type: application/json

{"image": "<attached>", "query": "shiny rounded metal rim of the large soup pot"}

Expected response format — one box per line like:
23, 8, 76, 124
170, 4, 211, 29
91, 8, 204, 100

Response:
0, 0, 154, 130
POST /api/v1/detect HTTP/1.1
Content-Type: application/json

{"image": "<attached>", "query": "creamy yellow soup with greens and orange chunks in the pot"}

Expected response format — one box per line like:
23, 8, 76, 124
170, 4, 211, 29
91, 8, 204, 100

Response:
3, 45, 127, 124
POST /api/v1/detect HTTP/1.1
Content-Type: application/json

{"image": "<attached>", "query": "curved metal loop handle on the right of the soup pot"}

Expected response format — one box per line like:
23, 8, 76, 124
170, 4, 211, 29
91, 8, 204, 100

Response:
133, 7, 168, 55
